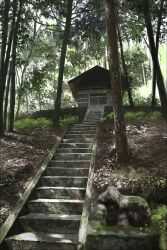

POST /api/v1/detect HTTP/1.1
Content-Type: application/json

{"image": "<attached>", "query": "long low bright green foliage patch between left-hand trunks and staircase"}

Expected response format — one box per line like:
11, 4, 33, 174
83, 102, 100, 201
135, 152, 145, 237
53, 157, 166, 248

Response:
15, 117, 53, 131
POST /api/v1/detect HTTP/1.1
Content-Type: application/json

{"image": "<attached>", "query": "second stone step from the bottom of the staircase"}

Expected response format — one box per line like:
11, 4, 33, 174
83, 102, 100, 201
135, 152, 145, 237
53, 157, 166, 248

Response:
19, 213, 81, 234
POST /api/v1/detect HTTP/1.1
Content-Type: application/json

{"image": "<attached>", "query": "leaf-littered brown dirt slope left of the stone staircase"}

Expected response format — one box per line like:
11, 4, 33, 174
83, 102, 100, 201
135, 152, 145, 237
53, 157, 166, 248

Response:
0, 128, 62, 226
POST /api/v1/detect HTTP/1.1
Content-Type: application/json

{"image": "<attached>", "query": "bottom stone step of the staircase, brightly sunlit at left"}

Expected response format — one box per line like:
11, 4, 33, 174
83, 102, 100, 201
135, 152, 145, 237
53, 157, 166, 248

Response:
5, 233, 77, 250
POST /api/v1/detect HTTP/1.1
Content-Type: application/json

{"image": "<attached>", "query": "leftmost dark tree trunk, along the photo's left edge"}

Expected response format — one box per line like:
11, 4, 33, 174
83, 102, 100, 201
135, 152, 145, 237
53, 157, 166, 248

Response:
0, 0, 10, 137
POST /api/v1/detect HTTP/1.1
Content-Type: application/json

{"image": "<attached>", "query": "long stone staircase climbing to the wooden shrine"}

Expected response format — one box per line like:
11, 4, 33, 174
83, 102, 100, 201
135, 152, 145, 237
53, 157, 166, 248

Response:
5, 111, 103, 250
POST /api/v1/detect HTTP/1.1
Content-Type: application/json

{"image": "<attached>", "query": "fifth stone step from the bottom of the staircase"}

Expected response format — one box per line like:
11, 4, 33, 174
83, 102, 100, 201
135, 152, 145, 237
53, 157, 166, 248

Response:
40, 176, 88, 187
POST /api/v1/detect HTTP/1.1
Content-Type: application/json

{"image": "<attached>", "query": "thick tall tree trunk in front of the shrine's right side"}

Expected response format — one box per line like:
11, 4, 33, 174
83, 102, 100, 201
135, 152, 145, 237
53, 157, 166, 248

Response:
105, 0, 129, 164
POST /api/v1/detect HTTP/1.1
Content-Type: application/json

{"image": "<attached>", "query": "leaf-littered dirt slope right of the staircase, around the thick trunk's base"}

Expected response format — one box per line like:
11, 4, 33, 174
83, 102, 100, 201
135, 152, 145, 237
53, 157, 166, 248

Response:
94, 121, 167, 204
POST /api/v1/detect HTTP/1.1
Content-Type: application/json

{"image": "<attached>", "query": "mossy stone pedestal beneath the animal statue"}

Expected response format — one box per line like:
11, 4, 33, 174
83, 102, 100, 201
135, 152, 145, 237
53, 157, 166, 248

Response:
85, 226, 160, 250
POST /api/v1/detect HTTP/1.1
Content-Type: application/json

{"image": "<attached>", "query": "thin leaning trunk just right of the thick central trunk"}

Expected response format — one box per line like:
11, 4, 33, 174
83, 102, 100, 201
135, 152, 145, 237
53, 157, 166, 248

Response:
117, 25, 134, 108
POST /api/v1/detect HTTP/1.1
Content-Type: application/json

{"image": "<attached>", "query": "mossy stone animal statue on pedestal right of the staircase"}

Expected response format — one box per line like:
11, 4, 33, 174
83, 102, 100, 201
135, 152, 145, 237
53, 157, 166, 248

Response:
99, 186, 151, 227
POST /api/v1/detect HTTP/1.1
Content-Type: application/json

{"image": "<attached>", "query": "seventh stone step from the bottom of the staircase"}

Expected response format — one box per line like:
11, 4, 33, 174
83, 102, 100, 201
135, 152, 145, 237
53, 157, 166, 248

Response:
50, 160, 90, 168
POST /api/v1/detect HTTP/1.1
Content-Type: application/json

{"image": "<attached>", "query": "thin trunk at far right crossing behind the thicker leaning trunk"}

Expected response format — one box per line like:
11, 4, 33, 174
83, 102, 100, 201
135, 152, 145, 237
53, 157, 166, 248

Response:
151, 0, 165, 109
